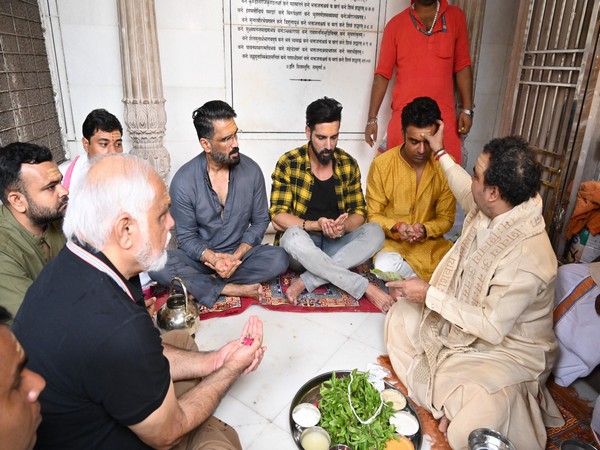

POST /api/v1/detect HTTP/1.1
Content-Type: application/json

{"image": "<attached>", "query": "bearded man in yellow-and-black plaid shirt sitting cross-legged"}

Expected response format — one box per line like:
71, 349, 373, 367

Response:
269, 97, 394, 313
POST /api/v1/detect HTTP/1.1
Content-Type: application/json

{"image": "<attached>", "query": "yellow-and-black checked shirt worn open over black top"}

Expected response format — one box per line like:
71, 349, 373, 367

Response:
269, 144, 367, 244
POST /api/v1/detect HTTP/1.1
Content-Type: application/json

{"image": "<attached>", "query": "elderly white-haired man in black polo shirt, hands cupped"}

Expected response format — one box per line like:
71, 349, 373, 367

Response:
14, 155, 265, 449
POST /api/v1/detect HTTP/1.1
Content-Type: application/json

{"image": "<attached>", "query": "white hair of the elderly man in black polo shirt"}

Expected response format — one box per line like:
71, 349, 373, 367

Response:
63, 154, 158, 250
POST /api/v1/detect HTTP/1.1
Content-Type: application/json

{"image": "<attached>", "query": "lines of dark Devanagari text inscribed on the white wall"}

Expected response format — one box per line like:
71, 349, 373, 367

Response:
236, 0, 379, 76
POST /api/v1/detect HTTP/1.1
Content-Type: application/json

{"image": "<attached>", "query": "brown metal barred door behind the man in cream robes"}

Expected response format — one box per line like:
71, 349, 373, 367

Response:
500, 0, 600, 243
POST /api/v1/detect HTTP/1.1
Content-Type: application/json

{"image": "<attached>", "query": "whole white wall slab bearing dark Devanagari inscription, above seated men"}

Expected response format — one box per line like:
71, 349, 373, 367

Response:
229, 0, 382, 129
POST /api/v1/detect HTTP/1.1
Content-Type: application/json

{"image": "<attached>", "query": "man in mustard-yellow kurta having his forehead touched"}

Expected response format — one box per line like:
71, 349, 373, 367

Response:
366, 97, 456, 281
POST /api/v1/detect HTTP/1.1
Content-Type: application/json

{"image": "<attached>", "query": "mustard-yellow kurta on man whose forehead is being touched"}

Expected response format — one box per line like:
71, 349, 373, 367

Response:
366, 147, 456, 281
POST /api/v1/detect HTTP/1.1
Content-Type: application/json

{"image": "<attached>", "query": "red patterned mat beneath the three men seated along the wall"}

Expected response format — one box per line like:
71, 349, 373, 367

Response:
155, 264, 383, 320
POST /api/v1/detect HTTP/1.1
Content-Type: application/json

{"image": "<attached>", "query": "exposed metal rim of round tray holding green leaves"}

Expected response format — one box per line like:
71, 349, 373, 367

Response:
289, 370, 423, 450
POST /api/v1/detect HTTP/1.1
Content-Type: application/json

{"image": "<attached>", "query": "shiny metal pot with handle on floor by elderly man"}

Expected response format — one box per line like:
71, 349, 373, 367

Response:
157, 277, 200, 335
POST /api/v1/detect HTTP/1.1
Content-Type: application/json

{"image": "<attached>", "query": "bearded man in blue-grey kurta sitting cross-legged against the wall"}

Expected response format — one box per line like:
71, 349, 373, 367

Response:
150, 100, 288, 307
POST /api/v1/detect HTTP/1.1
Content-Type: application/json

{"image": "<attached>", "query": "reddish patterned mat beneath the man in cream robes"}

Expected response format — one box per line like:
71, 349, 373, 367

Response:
378, 355, 596, 450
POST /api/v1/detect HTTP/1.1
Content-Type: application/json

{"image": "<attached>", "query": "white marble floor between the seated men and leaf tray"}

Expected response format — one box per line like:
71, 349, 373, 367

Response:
196, 306, 599, 450
